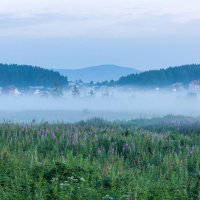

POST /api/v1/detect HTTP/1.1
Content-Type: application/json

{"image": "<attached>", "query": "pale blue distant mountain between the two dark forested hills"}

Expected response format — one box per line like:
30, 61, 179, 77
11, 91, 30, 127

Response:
56, 65, 139, 83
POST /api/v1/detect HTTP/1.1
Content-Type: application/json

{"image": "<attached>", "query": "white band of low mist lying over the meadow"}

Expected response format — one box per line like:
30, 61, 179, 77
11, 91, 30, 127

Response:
0, 88, 200, 122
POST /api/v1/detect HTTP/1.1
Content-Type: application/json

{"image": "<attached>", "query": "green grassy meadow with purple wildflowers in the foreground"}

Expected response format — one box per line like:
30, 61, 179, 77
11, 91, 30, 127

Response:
0, 116, 200, 200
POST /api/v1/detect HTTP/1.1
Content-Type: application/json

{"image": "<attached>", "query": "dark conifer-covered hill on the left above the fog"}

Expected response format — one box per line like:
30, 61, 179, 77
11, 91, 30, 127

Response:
0, 64, 68, 87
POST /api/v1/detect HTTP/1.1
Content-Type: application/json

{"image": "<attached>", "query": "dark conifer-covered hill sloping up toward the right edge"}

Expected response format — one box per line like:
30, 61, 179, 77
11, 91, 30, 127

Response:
116, 64, 200, 87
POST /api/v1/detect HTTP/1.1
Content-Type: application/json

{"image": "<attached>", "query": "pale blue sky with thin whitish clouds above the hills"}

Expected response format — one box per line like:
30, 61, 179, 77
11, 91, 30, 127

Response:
0, 0, 200, 70
